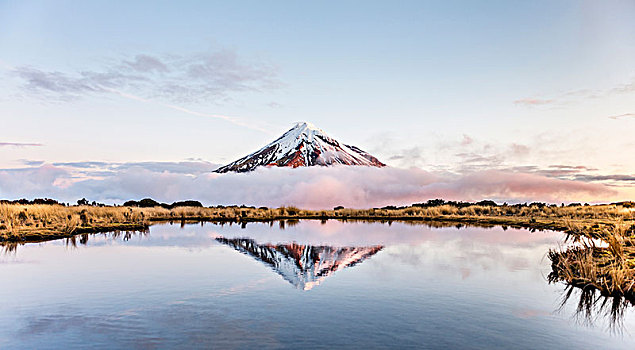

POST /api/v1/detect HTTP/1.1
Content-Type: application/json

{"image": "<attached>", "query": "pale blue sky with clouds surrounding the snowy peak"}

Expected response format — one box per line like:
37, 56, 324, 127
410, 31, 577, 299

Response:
0, 0, 635, 207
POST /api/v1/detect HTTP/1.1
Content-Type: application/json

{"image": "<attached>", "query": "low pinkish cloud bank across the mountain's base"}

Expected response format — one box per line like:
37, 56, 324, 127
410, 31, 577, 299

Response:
0, 162, 617, 209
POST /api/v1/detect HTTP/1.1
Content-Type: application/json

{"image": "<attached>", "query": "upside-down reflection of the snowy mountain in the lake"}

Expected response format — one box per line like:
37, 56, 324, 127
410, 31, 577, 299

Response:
216, 237, 384, 290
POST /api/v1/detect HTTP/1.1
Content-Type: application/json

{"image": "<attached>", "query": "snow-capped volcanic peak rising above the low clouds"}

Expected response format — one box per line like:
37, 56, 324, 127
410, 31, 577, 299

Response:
214, 122, 386, 173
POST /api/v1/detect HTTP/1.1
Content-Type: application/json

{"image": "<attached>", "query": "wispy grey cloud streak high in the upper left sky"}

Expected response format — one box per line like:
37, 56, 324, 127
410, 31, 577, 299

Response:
12, 50, 280, 103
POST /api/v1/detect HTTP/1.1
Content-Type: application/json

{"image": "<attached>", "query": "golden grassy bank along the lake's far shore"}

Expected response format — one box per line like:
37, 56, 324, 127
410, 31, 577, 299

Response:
0, 204, 634, 241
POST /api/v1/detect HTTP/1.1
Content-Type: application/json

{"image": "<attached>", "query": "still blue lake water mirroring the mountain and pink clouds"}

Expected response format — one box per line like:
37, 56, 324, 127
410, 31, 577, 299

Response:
0, 220, 635, 349
